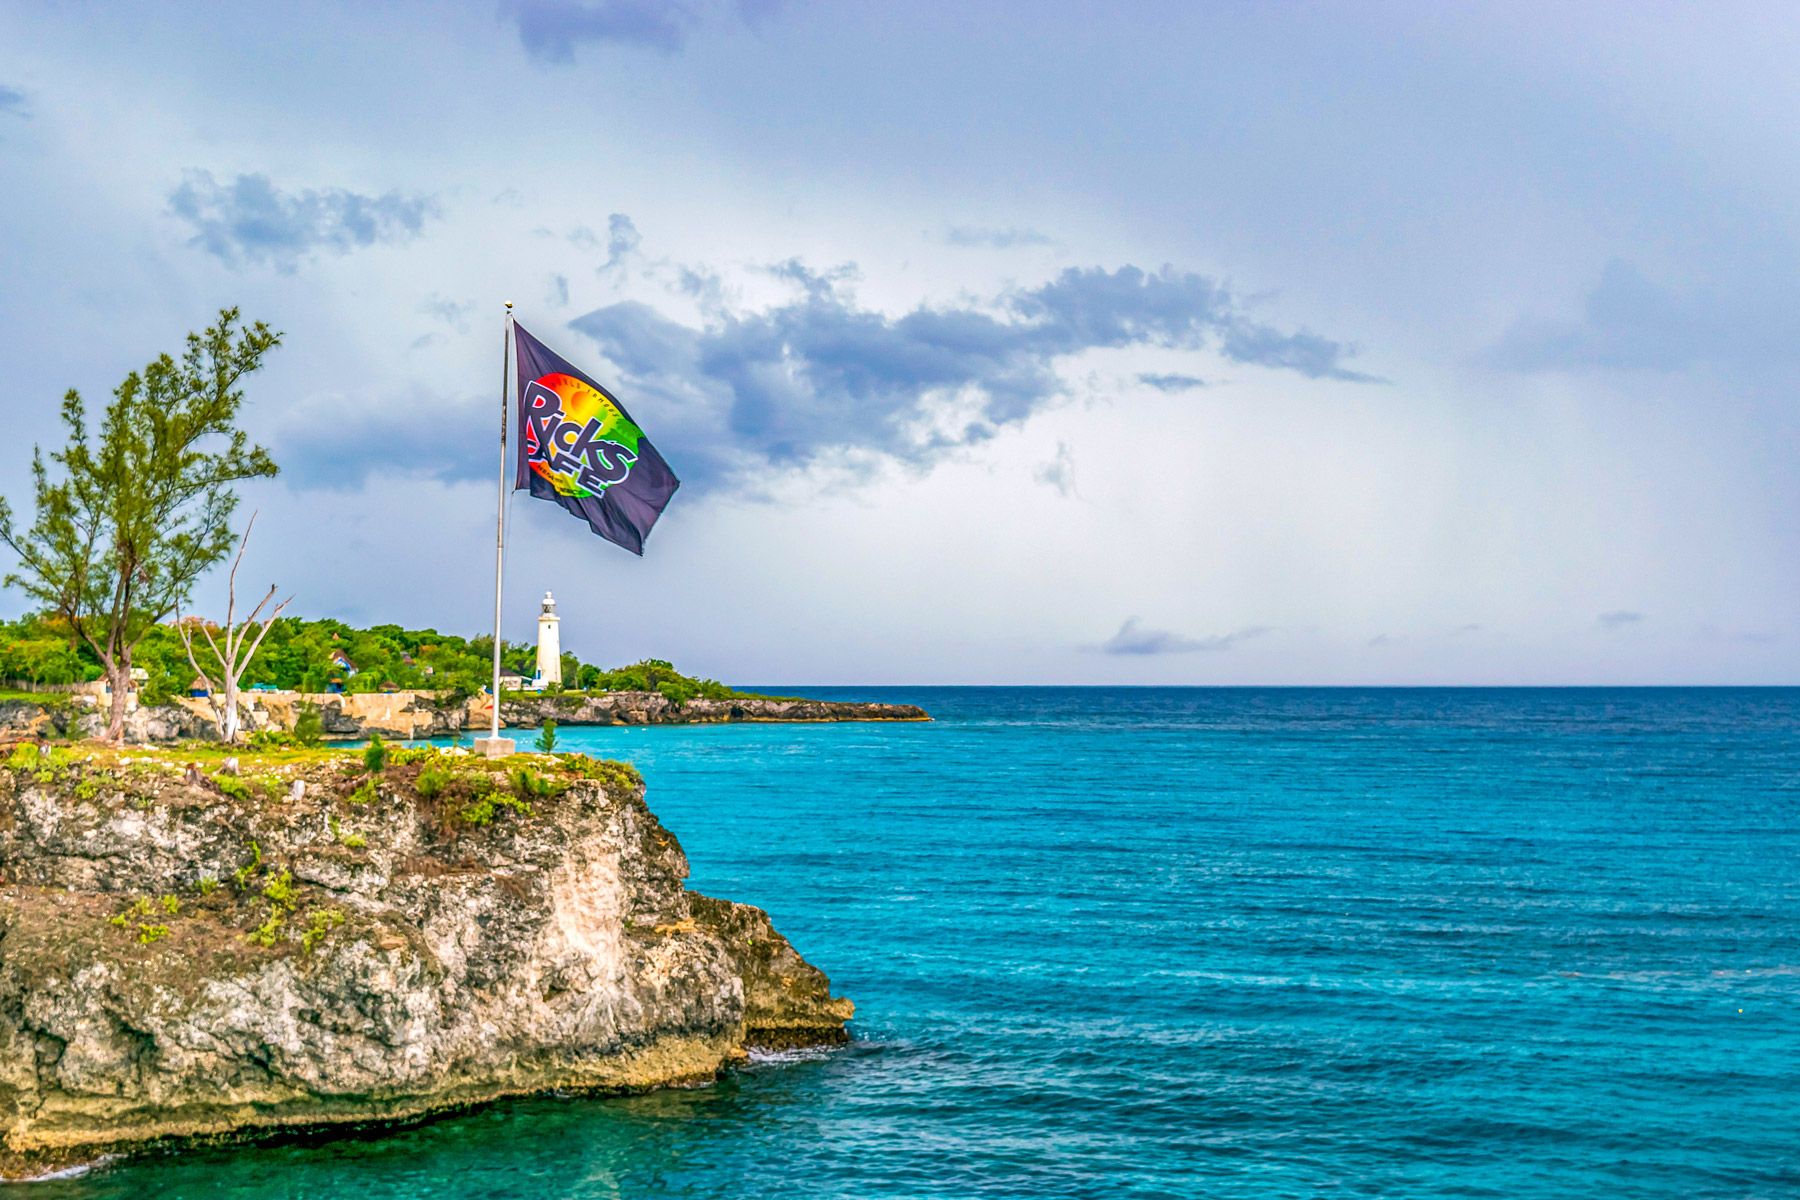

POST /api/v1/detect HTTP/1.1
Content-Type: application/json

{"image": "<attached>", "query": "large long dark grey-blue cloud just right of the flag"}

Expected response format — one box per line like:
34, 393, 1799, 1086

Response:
569, 261, 1370, 486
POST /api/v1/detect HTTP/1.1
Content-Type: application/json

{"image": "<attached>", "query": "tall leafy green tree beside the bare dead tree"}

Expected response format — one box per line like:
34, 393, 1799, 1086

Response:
0, 308, 281, 743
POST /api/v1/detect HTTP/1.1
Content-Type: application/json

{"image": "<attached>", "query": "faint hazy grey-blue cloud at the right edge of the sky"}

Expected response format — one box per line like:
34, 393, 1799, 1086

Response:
1487, 259, 1800, 372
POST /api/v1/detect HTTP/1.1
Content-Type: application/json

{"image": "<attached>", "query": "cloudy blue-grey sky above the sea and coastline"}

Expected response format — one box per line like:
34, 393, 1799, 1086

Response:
0, 0, 1800, 685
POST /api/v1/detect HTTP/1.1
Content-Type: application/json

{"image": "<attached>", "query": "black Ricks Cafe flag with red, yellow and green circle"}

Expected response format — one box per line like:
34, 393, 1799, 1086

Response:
513, 322, 680, 554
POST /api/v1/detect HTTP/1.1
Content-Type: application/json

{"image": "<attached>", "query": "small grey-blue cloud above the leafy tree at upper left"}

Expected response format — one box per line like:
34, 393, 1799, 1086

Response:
169, 171, 437, 272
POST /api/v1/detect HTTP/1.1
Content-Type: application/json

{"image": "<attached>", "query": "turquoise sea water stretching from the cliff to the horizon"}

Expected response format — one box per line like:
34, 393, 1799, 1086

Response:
32, 689, 1800, 1200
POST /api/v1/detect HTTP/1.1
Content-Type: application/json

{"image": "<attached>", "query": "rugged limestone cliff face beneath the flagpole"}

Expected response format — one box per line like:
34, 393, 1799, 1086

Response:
0, 752, 851, 1175
